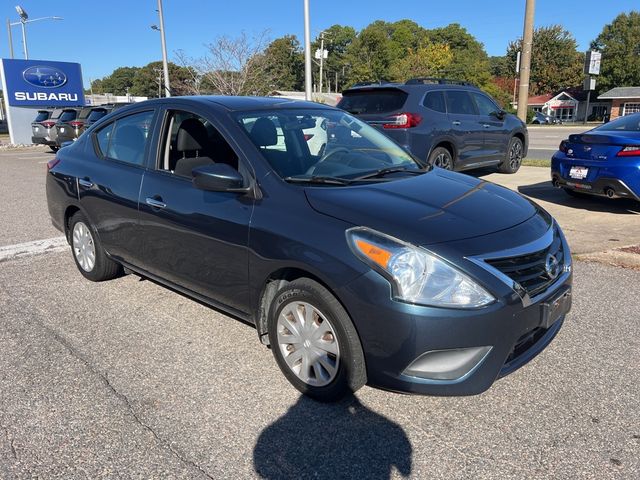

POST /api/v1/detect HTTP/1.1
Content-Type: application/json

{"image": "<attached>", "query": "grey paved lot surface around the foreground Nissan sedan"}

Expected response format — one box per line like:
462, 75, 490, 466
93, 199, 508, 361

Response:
0, 149, 640, 479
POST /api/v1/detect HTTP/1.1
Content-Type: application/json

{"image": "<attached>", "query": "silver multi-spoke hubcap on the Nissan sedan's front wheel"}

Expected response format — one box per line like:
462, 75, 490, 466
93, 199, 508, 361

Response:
278, 302, 340, 387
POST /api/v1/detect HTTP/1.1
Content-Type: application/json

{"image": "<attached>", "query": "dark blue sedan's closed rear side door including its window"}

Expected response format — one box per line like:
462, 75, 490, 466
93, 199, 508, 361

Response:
77, 109, 156, 265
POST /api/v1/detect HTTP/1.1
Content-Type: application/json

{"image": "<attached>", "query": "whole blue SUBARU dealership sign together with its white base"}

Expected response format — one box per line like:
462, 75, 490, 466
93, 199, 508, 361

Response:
0, 58, 85, 144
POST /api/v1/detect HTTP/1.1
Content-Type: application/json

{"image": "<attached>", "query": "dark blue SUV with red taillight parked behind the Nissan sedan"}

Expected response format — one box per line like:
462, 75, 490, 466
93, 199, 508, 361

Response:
337, 78, 528, 173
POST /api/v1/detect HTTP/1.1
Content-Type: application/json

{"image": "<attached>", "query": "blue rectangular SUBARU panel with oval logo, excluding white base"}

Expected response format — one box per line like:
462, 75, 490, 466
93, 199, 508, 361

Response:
2, 59, 84, 107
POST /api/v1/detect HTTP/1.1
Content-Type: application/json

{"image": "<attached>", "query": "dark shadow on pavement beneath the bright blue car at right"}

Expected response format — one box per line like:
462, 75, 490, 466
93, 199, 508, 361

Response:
518, 181, 640, 215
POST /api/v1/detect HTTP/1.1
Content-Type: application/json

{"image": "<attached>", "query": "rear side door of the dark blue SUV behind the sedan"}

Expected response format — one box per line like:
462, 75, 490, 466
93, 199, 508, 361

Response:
445, 90, 486, 167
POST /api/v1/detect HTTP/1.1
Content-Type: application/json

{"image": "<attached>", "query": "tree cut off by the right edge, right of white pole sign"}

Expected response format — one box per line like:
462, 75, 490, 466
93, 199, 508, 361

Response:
591, 11, 640, 91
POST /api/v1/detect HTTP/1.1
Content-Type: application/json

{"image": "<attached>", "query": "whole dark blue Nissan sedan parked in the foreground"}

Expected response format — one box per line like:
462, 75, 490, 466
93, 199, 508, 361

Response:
46, 97, 572, 401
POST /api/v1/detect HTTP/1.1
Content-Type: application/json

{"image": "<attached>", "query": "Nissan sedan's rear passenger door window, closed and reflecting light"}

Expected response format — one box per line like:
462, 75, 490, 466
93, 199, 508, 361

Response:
96, 111, 154, 165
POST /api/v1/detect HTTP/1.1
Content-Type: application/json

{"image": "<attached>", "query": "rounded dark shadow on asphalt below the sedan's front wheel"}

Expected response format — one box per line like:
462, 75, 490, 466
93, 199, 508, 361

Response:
253, 395, 413, 479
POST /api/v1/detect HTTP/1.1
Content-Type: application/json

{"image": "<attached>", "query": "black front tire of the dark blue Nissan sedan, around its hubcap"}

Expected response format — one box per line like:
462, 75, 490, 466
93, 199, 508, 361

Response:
267, 278, 367, 402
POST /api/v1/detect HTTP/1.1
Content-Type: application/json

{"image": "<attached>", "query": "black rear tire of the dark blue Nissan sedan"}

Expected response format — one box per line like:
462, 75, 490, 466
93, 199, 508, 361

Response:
69, 212, 122, 282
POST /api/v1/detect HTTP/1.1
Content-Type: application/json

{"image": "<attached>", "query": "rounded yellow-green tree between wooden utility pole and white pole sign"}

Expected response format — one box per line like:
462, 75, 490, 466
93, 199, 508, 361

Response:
507, 25, 584, 95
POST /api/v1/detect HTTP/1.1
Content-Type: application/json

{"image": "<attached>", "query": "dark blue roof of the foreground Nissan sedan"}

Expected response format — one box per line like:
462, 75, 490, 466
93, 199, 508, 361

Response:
115, 95, 334, 111
